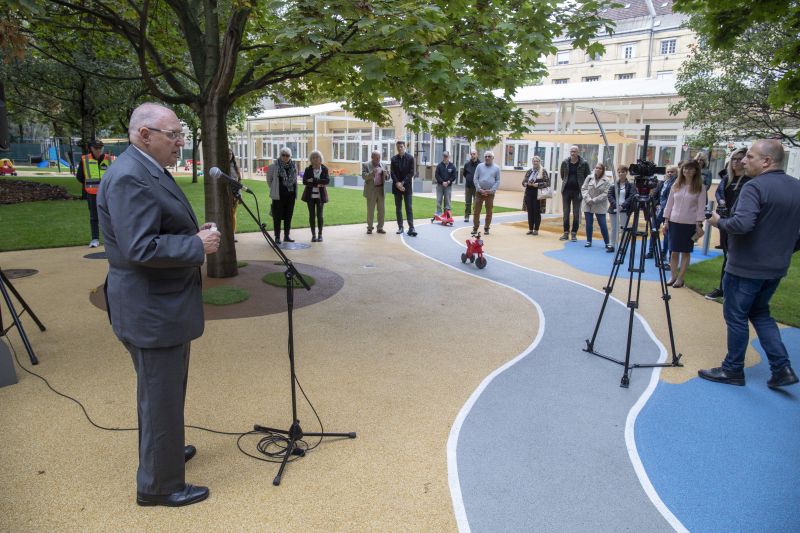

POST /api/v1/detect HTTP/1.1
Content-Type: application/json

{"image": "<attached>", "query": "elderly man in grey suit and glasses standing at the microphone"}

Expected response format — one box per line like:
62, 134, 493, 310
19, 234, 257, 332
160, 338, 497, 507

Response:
97, 103, 220, 507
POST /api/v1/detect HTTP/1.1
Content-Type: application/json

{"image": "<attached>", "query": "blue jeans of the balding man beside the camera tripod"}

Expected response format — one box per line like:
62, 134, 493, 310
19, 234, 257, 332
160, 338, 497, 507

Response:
722, 272, 789, 372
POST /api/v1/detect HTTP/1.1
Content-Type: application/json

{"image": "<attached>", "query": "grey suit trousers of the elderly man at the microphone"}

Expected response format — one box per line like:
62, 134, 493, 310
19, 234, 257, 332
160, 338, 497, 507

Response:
124, 342, 191, 494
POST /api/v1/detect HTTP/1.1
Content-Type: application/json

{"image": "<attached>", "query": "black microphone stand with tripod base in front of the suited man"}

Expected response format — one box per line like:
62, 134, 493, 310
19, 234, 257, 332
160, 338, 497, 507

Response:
231, 183, 356, 486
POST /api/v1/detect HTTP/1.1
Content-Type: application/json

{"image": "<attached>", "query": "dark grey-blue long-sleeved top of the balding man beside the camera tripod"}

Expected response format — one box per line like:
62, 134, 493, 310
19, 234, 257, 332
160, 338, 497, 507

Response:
719, 170, 800, 279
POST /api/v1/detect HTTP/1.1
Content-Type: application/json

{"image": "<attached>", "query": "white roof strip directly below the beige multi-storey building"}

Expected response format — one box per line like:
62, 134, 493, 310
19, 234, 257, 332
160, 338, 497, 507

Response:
506, 79, 678, 104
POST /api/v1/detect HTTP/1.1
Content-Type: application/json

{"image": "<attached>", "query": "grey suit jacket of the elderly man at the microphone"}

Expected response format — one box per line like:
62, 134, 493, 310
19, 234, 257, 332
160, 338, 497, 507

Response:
97, 146, 205, 348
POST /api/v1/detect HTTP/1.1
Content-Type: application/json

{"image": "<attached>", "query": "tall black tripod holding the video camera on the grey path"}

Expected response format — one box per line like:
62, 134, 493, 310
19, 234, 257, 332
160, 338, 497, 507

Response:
583, 194, 683, 388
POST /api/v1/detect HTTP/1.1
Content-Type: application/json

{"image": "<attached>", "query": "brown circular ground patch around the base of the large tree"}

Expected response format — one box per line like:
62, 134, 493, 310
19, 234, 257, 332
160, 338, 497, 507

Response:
89, 261, 344, 320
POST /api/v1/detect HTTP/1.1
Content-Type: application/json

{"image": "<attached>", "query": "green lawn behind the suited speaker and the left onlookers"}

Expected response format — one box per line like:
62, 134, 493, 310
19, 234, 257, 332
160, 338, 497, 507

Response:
0, 175, 513, 252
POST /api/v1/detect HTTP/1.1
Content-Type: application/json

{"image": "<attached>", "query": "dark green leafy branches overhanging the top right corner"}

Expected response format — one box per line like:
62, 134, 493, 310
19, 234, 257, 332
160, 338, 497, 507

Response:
674, 0, 800, 110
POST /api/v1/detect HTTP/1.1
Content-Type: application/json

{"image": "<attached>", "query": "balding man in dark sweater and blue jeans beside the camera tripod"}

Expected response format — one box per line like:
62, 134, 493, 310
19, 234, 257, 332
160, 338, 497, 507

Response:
697, 140, 800, 388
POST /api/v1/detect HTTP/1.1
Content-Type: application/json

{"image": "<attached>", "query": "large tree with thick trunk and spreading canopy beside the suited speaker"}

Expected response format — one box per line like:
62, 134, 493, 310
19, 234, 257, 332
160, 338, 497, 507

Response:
25, 0, 612, 277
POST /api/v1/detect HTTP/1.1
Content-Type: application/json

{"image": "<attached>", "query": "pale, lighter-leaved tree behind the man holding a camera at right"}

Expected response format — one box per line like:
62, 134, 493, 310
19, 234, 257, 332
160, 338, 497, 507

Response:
670, 17, 800, 146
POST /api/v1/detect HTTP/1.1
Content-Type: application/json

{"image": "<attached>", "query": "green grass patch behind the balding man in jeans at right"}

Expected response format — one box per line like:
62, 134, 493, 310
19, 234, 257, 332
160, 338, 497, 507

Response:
686, 253, 800, 327
